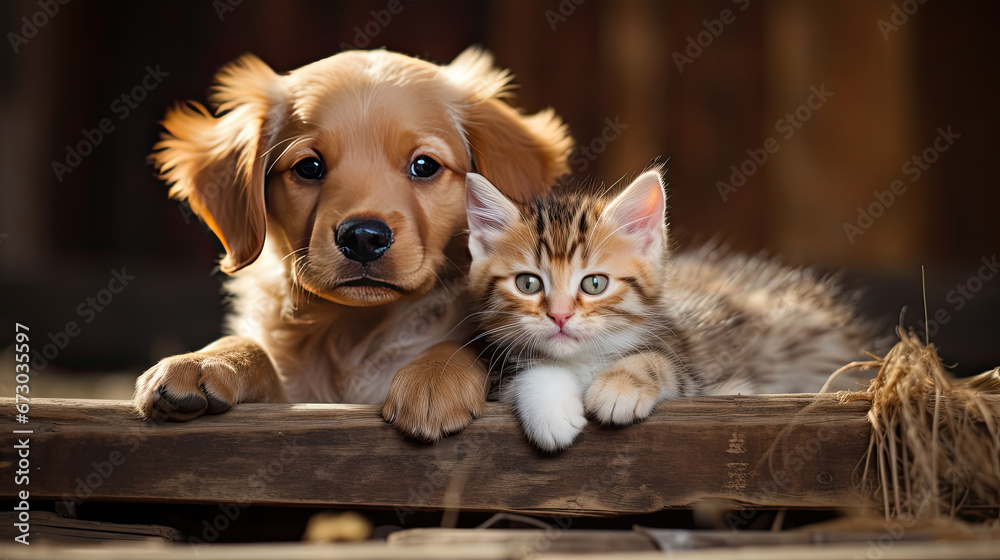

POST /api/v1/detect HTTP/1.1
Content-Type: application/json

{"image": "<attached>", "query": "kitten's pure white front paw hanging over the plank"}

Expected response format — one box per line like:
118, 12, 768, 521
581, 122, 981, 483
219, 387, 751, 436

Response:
514, 366, 587, 452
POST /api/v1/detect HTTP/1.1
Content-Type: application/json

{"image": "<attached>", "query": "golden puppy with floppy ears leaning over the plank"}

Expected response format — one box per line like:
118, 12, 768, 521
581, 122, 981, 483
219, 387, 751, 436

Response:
134, 49, 572, 440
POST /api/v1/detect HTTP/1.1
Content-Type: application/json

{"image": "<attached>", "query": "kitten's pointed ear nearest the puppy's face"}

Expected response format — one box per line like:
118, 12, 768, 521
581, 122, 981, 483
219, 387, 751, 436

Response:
465, 173, 521, 259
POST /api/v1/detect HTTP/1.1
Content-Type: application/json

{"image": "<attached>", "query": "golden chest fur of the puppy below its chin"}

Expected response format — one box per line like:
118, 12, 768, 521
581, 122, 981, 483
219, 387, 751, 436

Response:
226, 243, 471, 404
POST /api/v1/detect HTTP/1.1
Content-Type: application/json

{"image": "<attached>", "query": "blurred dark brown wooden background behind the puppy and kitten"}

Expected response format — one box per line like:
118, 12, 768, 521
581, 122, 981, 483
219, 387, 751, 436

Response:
0, 0, 1000, 396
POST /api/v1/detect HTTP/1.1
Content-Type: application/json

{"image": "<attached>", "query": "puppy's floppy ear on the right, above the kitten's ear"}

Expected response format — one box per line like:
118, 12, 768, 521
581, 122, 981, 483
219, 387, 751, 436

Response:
445, 47, 573, 200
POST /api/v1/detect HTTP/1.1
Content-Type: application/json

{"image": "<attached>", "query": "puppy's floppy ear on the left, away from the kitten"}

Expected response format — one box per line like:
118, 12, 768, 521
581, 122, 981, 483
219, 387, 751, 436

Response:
150, 55, 286, 273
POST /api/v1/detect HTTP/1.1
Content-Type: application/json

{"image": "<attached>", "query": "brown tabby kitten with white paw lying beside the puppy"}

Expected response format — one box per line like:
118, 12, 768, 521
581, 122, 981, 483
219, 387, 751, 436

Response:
466, 171, 871, 451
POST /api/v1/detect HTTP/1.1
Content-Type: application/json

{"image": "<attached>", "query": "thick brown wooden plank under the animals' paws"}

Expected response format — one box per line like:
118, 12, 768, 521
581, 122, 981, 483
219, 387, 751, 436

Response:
0, 395, 869, 523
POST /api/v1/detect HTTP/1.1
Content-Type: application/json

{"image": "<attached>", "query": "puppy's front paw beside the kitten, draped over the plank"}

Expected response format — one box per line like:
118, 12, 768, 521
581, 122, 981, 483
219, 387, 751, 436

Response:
382, 354, 486, 442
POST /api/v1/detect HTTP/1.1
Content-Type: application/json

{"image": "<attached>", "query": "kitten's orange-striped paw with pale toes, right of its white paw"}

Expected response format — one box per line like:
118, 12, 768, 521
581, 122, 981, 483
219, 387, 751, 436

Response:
585, 370, 660, 426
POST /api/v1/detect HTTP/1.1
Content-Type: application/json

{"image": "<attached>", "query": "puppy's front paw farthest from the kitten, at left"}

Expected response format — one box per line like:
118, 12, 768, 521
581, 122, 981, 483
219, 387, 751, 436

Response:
133, 353, 236, 421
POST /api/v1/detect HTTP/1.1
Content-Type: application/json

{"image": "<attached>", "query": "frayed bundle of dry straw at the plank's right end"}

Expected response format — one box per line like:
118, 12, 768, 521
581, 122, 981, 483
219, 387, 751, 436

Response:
831, 329, 1000, 521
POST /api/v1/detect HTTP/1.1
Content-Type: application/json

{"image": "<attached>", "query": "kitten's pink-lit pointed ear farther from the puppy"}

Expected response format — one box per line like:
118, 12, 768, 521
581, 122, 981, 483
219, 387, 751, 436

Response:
601, 171, 667, 252
